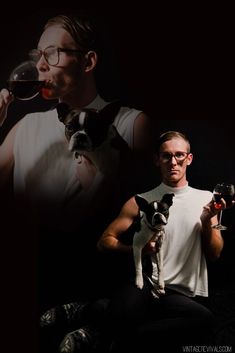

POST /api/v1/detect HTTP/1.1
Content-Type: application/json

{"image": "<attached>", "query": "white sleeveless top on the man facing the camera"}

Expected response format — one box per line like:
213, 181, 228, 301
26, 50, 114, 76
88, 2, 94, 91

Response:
142, 183, 212, 297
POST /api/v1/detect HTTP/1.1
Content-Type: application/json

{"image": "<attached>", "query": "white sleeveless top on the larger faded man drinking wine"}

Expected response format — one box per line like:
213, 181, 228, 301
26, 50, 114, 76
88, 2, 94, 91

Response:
14, 96, 140, 230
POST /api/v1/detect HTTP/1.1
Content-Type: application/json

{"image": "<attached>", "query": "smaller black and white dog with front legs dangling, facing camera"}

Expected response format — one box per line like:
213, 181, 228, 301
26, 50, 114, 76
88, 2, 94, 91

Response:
133, 194, 174, 298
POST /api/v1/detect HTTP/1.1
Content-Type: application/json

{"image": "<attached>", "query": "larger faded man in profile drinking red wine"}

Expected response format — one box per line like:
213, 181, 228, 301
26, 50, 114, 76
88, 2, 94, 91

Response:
0, 16, 154, 223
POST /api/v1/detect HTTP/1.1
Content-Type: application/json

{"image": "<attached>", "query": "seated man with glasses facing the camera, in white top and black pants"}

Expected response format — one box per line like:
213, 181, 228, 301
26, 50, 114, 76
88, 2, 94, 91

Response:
98, 131, 226, 352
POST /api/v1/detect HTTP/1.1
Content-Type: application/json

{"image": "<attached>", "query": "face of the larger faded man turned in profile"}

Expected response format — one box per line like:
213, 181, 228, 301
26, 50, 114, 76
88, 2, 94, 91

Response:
37, 25, 85, 99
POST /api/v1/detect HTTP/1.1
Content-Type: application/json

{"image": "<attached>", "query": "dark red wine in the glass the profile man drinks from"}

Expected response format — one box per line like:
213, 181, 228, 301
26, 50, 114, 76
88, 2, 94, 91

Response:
8, 80, 44, 99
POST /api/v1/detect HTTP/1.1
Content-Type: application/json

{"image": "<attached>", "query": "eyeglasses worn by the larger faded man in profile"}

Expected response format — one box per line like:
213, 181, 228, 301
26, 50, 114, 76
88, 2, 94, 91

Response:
29, 45, 82, 66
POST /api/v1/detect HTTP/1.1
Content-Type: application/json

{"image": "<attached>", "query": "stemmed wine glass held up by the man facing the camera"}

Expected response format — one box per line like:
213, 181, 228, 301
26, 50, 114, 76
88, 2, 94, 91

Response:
212, 183, 235, 230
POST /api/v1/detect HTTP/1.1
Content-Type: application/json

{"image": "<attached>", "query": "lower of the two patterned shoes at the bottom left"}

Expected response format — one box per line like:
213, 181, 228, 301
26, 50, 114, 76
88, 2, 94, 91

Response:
59, 326, 100, 353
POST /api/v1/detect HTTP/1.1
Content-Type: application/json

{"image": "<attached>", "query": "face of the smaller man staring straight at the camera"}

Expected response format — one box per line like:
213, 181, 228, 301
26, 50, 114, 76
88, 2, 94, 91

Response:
156, 138, 193, 187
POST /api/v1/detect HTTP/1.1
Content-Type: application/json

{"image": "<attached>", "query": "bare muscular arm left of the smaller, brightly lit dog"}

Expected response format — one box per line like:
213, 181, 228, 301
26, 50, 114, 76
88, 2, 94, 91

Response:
97, 197, 138, 253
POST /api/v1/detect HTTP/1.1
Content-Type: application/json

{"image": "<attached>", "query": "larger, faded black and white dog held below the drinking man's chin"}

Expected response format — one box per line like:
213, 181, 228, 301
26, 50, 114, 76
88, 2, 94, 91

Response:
57, 101, 129, 186
